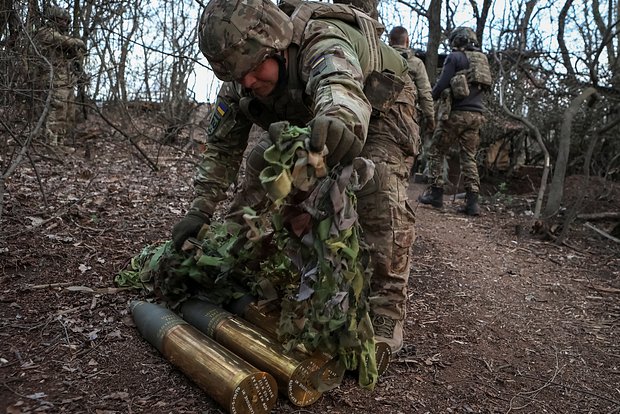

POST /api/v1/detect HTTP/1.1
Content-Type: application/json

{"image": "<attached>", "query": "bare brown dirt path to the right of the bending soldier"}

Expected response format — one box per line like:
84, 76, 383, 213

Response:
298, 185, 620, 413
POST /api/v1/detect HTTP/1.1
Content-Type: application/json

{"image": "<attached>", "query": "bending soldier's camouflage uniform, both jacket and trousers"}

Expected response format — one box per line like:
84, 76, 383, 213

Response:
191, 2, 420, 350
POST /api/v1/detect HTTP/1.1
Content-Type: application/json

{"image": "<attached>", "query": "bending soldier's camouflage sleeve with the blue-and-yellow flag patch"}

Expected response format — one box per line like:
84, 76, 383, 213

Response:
191, 82, 252, 217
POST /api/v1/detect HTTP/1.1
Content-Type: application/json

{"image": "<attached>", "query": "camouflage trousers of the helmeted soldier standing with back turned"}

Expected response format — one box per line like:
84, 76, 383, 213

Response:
428, 111, 485, 193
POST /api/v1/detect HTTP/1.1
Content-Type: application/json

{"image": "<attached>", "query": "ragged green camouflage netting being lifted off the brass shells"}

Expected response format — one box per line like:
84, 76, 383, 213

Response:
115, 122, 378, 389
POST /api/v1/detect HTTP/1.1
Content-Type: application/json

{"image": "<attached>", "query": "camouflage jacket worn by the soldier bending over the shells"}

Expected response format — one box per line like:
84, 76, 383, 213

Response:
191, 12, 411, 216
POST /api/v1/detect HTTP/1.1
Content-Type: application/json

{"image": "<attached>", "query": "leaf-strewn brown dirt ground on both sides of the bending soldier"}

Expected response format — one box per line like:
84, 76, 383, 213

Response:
0, 127, 620, 414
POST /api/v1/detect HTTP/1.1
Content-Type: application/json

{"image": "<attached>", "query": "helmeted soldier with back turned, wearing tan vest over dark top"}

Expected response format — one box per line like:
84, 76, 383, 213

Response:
419, 27, 491, 216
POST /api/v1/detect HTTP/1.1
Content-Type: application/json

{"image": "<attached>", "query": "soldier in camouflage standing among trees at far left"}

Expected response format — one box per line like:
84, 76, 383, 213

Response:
35, 6, 86, 145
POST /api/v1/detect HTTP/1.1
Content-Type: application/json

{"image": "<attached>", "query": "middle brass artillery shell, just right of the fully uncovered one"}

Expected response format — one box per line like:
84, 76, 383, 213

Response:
181, 299, 323, 407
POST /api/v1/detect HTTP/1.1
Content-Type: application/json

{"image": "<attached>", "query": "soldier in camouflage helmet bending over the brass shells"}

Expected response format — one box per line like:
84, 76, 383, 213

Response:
172, 0, 419, 352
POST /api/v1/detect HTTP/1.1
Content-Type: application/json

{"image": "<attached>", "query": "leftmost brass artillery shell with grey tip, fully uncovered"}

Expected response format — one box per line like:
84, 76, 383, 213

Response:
131, 301, 278, 414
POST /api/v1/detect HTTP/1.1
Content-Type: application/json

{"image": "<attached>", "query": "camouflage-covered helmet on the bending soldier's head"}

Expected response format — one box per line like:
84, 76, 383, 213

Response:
198, 0, 293, 81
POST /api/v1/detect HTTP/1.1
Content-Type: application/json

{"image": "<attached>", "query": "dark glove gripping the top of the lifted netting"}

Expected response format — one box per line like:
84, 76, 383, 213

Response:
308, 115, 364, 167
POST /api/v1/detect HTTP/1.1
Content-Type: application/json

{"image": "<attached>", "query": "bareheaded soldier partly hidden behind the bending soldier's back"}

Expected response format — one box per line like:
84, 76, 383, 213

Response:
389, 26, 435, 136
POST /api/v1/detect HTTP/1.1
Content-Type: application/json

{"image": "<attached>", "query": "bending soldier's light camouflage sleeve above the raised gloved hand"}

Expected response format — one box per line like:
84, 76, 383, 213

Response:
300, 20, 371, 142
